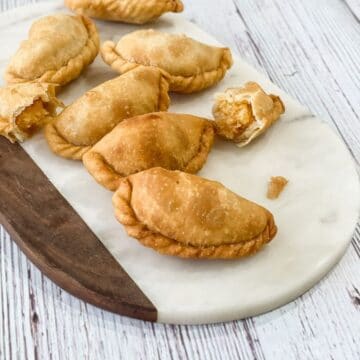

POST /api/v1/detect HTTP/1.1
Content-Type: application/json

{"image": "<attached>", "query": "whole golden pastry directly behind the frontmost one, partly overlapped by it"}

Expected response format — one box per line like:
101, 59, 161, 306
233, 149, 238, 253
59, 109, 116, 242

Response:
83, 112, 214, 191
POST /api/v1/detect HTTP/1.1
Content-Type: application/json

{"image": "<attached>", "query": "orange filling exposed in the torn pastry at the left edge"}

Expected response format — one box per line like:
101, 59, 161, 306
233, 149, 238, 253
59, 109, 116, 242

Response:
15, 99, 49, 135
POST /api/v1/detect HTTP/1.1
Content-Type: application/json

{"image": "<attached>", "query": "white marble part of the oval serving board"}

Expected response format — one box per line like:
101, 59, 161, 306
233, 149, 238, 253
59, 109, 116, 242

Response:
0, 2, 360, 324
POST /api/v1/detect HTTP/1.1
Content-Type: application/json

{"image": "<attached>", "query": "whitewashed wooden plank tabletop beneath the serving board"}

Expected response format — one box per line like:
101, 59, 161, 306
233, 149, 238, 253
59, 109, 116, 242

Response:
0, 0, 360, 360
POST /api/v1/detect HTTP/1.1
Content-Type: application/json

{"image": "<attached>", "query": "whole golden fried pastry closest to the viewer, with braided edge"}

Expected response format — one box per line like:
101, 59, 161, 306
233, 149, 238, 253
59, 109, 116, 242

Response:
113, 168, 277, 259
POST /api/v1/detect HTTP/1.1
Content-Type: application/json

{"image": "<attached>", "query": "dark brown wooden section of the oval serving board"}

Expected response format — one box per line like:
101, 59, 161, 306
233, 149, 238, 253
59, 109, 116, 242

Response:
0, 138, 157, 321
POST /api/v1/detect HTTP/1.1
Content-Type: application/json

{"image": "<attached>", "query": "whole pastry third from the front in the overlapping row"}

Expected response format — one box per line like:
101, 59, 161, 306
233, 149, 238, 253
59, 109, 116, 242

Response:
45, 67, 170, 160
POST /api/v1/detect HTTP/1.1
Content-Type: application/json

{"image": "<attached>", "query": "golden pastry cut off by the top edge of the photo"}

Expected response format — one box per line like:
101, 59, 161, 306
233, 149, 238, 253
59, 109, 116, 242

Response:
65, 0, 184, 24
